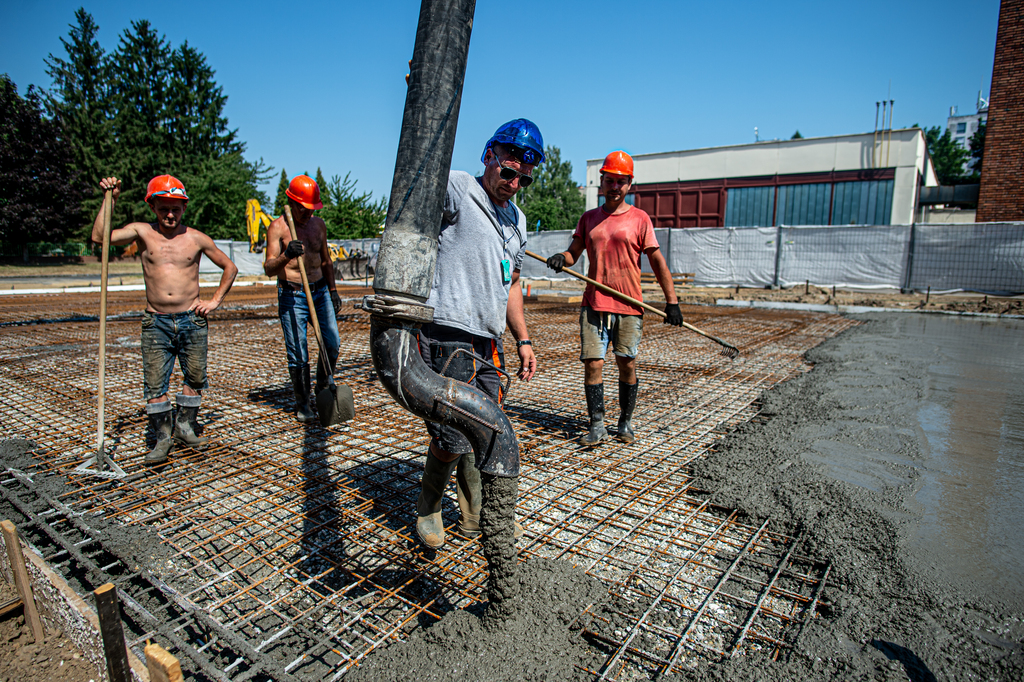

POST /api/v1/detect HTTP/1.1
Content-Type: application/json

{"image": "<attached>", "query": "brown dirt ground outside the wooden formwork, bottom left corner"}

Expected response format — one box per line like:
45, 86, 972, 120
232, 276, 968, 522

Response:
0, 581, 96, 682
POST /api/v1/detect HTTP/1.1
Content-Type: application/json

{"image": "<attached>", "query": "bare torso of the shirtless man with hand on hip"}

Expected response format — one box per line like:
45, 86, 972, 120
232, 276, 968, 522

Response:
136, 223, 203, 313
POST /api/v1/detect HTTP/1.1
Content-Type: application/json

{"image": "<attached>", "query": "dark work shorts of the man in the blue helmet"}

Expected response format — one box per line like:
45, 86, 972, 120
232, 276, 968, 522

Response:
419, 324, 505, 455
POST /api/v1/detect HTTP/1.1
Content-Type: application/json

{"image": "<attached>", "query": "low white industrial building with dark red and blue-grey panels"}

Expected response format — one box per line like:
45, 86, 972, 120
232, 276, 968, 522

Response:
586, 128, 938, 227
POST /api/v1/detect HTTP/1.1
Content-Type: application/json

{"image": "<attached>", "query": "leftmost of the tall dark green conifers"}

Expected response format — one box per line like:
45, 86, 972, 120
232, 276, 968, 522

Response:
44, 8, 112, 227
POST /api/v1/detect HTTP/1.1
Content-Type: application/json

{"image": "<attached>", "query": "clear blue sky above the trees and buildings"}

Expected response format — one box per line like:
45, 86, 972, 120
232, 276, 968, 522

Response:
0, 0, 999, 197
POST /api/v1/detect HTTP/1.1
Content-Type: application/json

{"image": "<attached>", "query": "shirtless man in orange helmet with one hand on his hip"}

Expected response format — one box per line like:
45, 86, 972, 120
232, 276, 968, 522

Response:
92, 175, 239, 464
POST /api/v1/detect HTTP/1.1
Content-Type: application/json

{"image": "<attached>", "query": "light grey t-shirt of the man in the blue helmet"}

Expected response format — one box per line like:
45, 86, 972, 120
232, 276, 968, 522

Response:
427, 171, 526, 339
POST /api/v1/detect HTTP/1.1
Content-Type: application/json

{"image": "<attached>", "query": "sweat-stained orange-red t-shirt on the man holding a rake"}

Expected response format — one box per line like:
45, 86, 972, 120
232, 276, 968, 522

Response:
572, 206, 657, 315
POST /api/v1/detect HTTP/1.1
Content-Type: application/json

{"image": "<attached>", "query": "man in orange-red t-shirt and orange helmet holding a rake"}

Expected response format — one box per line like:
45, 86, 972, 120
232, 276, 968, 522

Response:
547, 152, 683, 445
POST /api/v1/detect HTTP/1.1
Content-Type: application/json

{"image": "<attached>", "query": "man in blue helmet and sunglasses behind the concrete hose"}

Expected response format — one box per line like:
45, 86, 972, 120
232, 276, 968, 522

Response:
416, 119, 544, 549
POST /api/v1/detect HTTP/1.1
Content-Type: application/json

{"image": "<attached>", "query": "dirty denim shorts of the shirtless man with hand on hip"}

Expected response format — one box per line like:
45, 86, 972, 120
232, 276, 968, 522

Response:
142, 310, 210, 400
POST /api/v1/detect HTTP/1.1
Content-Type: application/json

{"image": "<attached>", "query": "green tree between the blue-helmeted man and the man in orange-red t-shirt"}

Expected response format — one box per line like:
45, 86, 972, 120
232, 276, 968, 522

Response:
516, 145, 586, 230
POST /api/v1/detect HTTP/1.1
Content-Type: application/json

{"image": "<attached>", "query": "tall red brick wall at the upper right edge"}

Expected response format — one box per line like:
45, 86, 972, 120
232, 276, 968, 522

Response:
977, 0, 1024, 222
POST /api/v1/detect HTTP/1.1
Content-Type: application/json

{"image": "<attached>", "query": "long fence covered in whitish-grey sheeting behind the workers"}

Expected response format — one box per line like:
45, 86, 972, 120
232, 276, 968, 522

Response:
200, 222, 1024, 295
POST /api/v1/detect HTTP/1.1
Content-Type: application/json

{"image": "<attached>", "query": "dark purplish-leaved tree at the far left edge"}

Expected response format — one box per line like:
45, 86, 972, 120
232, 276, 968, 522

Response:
0, 74, 84, 260
